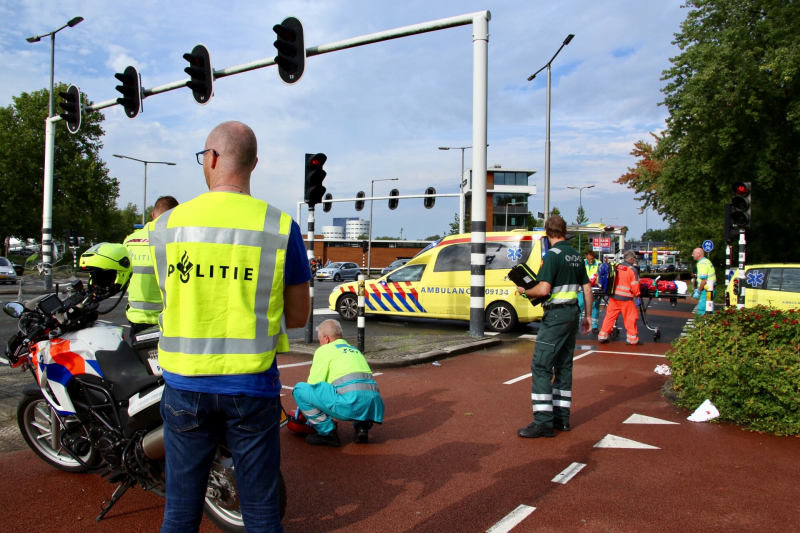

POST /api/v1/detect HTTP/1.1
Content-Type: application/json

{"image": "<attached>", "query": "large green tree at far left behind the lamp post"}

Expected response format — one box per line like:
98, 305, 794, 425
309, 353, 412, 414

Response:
0, 83, 119, 248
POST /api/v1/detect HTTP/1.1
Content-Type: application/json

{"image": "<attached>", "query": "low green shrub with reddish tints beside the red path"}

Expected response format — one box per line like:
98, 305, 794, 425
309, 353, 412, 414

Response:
667, 306, 800, 435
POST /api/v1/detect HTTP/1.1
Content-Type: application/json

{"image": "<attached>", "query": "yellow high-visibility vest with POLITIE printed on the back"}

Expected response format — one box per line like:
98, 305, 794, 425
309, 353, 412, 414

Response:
148, 192, 292, 376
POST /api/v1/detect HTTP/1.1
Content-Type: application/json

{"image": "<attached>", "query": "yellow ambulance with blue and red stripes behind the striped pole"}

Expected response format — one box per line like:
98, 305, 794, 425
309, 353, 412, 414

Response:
328, 230, 550, 332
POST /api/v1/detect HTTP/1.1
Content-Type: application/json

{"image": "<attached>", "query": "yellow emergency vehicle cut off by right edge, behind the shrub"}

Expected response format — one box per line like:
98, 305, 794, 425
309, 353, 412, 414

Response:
717, 263, 800, 310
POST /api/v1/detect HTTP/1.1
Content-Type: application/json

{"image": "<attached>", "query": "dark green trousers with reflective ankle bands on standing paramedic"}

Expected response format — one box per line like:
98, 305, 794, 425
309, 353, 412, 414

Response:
531, 305, 580, 428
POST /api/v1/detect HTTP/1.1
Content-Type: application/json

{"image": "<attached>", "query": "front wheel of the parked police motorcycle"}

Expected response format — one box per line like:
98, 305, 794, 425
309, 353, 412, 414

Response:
17, 394, 96, 473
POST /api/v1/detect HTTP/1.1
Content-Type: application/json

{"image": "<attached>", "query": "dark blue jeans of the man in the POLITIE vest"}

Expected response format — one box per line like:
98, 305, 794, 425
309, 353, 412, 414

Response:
161, 385, 283, 533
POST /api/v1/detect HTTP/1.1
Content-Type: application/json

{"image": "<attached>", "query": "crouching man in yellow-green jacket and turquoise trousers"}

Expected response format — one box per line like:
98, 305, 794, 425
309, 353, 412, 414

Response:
292, 320, 384, 448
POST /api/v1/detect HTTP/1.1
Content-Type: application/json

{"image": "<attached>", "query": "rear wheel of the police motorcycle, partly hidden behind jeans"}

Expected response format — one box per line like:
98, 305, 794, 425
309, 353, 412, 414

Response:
203, 447, 286, 533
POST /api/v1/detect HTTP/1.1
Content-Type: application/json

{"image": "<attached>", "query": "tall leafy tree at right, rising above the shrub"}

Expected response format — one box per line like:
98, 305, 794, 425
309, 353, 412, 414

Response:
618, 0, 800, 265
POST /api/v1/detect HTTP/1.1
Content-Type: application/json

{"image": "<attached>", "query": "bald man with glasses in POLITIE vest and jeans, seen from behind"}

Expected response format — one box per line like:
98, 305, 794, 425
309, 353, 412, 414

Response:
148, 122, 311, 533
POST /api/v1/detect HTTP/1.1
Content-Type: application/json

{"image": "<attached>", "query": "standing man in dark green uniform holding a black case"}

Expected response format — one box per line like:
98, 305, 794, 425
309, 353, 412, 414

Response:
517, 216, 592, 439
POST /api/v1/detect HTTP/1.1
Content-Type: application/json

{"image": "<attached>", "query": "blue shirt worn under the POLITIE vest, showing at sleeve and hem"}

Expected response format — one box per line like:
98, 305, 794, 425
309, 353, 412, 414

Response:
164, 221, 311, 398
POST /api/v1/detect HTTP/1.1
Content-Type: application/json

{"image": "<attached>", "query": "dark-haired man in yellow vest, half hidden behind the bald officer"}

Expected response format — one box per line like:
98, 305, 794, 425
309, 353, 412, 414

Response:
122, 196, 178, 337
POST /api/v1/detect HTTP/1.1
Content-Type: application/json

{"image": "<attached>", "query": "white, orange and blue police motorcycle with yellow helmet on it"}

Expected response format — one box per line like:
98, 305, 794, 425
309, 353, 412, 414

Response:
3, 243, 286, 532
